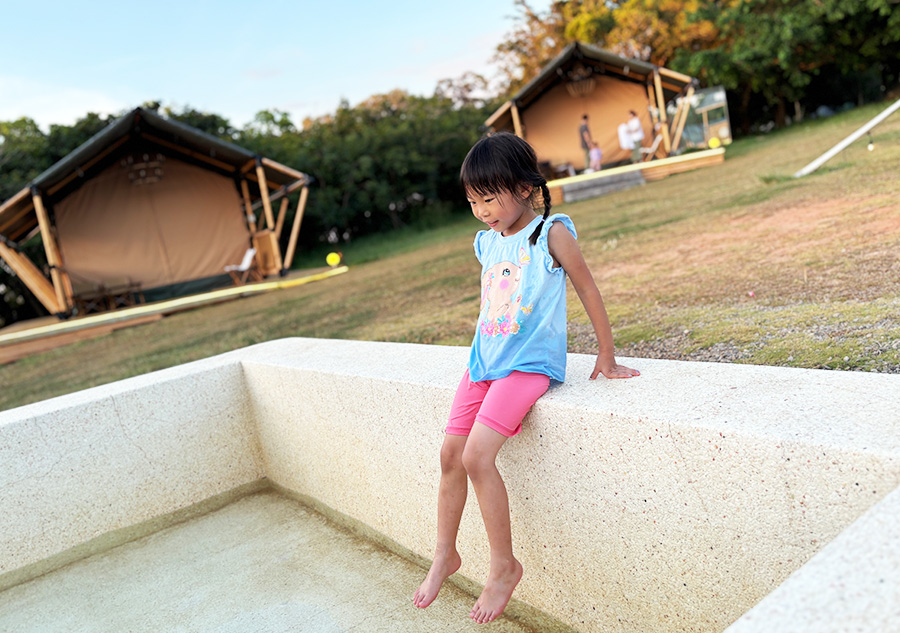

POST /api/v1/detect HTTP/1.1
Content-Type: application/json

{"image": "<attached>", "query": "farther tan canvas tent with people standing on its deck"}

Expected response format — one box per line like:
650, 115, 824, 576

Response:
485, 42, 696, 166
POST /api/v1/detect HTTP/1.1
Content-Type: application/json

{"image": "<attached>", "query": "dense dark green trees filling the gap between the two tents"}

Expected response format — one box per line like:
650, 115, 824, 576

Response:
237, 88, 488, 254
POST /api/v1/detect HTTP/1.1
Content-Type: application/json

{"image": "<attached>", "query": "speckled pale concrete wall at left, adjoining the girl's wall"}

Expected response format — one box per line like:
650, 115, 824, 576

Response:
0, 358, 264, 588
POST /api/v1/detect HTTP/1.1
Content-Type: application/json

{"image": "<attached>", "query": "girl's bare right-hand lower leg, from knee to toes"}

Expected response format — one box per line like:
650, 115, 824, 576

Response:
462, 423, 522, 624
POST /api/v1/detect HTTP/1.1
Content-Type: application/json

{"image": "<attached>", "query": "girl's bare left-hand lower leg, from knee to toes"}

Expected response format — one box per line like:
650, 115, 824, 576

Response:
413, 434, 468, 609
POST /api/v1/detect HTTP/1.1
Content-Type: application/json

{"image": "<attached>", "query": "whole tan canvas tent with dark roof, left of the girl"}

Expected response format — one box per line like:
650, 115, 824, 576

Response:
0, 108, 311, 316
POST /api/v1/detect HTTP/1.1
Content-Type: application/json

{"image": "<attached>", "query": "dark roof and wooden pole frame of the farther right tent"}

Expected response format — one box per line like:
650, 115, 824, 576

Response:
485, 42, 698, 164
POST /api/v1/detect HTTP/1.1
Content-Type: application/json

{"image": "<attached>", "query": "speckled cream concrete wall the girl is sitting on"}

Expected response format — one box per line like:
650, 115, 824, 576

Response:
243, 340, 900, 633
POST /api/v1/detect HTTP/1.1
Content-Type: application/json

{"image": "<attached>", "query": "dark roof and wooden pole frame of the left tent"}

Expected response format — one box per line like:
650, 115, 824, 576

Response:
0, 108, 312, 318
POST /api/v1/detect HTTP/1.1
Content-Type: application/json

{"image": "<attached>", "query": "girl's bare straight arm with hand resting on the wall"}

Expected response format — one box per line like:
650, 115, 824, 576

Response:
547, 223, 641, 380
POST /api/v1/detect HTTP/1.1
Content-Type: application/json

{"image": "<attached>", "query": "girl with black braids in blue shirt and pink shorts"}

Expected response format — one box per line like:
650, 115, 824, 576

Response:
413, 133, 639, 623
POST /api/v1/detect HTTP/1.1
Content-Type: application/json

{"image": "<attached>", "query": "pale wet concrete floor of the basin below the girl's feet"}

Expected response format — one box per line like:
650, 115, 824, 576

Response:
0, 491, 533, 633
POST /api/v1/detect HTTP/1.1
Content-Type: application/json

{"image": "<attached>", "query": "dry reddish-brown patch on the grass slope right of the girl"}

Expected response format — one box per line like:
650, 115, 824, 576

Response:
598, 197, 900, 304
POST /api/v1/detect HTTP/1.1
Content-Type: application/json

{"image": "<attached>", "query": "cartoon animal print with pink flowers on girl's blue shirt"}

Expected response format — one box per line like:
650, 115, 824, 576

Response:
481, 248, 532, 336
